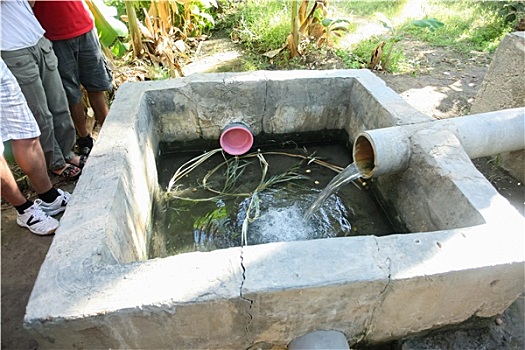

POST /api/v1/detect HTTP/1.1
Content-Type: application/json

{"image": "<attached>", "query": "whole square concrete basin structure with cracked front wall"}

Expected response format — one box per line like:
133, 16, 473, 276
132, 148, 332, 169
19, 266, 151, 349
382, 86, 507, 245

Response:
24, 70, 525, 349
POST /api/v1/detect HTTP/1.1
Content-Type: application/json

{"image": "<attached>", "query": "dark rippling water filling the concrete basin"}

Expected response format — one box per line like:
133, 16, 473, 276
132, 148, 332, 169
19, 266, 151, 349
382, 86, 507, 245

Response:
150, 141, 394, 257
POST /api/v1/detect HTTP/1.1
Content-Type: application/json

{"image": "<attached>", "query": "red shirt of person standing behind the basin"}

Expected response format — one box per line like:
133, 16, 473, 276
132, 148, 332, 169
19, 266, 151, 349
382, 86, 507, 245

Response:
33, 0, 93, 40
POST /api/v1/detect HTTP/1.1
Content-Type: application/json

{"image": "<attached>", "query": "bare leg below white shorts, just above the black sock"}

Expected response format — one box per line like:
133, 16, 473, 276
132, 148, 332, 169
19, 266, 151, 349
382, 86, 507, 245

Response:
10, 138, 53, 193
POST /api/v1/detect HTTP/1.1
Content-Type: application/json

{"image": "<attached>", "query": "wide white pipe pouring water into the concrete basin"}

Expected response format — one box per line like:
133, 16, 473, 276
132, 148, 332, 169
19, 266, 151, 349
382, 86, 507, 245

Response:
353, 108, 525, 179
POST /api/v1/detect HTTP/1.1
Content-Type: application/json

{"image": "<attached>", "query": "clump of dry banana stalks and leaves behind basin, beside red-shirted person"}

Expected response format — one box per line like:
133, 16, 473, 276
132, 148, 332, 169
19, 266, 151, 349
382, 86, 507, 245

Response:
86, 0, 217, 78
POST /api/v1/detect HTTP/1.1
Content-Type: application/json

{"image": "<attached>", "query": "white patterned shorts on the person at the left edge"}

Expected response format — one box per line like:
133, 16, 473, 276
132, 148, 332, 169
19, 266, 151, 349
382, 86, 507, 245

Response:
0, 58, 40, 143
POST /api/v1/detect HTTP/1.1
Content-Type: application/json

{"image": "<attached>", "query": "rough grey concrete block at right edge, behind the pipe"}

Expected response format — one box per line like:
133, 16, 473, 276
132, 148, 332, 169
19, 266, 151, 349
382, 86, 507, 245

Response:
470, 32, 525, 183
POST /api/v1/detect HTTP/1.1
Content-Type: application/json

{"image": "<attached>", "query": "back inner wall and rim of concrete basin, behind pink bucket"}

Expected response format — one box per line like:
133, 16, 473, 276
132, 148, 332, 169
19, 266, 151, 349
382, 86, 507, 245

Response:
146, 70, 431, 142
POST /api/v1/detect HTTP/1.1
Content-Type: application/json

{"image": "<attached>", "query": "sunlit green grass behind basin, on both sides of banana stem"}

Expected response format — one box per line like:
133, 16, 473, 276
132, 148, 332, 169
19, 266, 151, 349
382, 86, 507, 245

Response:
215, 0, 512, 73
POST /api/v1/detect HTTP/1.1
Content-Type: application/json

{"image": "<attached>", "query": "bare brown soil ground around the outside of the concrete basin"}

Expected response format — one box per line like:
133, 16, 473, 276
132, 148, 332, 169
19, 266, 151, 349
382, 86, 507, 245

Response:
1, 28, 525, 350
